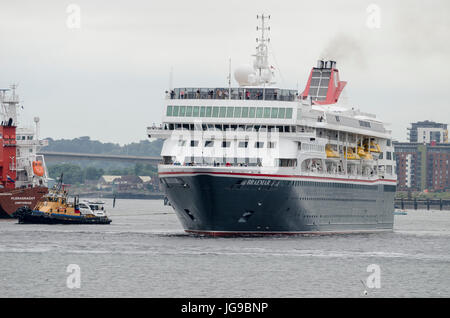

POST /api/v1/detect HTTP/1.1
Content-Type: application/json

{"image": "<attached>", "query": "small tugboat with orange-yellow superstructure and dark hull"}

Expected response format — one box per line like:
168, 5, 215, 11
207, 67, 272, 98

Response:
13, 176, 111, 224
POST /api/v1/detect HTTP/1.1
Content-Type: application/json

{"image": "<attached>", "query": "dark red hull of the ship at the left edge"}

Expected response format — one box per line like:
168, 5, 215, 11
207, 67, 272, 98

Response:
0, 187, 48, 218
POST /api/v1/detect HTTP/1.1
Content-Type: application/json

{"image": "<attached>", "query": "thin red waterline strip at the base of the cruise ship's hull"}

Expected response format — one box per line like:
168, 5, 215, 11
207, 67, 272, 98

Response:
185, 229, 393, 236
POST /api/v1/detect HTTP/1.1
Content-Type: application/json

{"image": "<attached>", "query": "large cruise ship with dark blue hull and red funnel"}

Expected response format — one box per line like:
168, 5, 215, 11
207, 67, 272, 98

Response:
147, 15, 397, 236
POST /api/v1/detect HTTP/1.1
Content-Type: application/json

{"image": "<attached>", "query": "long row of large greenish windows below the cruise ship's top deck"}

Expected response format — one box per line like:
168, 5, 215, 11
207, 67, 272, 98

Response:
166, 105, 292, 119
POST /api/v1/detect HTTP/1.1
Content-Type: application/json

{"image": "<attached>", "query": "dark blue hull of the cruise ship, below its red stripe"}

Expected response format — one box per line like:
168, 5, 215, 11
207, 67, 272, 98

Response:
160, 174, 395, 234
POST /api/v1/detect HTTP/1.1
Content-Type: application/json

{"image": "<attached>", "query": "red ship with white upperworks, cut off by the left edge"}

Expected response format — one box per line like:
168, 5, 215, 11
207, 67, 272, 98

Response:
0, 86, 48, 218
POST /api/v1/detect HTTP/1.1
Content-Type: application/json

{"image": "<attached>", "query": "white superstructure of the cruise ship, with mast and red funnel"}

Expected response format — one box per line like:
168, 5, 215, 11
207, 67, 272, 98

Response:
147, 15, 396, 180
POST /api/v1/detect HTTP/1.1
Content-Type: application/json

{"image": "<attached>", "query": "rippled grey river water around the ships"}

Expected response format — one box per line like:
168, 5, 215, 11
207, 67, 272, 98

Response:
0, 200, 450, 297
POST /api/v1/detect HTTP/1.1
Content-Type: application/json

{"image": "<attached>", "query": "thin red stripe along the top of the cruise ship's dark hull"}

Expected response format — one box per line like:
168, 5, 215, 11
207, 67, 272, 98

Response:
158, 171, 397, 183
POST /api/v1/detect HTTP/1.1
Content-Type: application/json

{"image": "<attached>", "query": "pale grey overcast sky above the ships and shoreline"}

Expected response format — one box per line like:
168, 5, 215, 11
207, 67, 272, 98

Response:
0, 0, 450, 144
